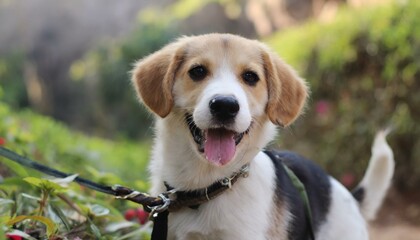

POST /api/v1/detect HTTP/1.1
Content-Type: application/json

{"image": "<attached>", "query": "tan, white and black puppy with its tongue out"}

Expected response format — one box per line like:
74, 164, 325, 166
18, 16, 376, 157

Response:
132, 33, 394, 240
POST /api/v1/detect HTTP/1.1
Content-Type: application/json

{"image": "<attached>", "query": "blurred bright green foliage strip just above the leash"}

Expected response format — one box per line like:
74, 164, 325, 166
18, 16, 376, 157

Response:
0, 102, 149, 190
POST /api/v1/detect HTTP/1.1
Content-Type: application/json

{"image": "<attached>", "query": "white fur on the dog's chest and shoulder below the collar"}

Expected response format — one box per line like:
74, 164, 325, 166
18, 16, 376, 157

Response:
169, 153, 275, 240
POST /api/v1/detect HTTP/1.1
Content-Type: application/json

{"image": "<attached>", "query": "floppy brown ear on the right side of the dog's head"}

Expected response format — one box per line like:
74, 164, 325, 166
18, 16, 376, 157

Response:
263, 51, 308, 127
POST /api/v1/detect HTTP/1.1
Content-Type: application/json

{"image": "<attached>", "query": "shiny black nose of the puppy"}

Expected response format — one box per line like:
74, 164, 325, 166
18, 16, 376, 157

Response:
209, 96, 239, 122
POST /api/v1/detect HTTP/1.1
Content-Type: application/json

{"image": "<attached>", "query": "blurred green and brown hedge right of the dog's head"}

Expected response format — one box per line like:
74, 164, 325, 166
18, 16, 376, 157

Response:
266, 0, 420, 190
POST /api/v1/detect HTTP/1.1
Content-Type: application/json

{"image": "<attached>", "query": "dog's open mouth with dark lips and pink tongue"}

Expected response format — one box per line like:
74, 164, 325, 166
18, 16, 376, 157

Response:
185, 114, 249, 166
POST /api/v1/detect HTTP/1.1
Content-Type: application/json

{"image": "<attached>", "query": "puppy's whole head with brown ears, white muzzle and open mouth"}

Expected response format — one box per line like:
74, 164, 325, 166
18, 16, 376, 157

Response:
132, 34, 307, 166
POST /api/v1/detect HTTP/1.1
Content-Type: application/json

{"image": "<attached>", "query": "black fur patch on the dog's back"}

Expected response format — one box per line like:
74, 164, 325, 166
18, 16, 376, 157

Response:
265, 150, 331, 240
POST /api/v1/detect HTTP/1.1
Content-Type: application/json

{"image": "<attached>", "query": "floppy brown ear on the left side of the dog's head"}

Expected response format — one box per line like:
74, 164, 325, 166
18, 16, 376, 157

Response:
131, 43, 183, 118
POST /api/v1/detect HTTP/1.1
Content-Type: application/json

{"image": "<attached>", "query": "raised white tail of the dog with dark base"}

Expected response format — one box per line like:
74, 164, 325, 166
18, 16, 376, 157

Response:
352, 130, 395, 220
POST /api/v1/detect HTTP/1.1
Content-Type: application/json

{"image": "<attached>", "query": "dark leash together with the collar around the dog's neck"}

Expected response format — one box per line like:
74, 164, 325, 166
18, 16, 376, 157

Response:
0, 147, 249, 240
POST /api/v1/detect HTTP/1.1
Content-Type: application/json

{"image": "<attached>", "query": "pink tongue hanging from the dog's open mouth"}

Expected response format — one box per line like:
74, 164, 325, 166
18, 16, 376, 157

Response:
204, 129, 236, 166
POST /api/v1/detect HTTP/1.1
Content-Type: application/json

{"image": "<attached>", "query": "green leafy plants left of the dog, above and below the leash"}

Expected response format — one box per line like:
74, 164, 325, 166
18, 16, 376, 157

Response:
0, 91, 154, 239
